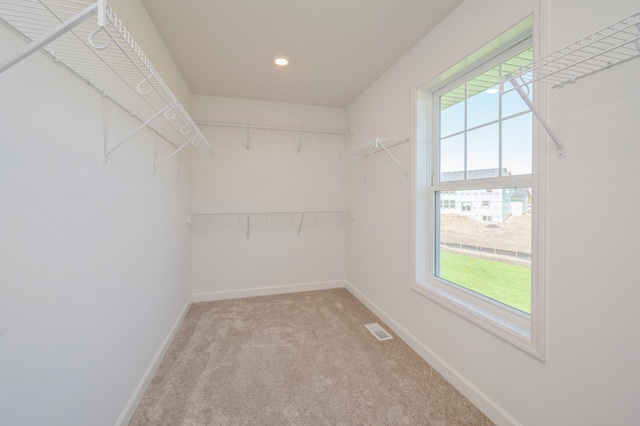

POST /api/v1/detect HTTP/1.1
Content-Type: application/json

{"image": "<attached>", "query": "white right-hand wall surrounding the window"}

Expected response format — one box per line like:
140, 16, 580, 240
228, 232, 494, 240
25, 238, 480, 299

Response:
347, 0, 640, 425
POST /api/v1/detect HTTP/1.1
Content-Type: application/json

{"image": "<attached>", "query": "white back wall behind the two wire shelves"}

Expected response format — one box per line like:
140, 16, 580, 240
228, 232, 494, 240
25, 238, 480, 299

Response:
192, 96, 346, 300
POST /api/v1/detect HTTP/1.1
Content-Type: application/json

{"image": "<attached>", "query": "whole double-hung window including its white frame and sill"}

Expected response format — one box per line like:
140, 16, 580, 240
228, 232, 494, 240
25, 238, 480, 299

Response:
412, 21, 544, 358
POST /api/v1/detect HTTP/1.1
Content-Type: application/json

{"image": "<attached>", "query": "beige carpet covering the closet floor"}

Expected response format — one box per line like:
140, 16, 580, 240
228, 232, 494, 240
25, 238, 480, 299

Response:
130, 289, 492, 426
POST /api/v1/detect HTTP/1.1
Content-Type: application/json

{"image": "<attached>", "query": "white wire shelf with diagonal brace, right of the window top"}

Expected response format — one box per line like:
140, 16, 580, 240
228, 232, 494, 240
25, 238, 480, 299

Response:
500, 12, 640, 157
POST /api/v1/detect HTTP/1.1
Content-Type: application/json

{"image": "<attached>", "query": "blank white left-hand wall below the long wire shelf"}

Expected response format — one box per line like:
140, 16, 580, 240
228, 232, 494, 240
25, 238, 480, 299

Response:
0, 2, 191, 425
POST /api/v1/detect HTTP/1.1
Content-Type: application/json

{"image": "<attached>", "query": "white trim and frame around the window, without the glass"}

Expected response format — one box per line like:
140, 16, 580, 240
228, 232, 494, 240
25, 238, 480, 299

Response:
411, 8, 547, 361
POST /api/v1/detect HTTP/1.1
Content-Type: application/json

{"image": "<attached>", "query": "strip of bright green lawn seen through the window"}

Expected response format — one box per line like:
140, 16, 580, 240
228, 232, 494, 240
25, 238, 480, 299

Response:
440, 251, 531, 314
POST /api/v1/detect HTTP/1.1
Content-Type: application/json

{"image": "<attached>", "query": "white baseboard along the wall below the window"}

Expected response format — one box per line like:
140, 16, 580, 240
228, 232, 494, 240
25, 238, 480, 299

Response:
345, 281, 521, 426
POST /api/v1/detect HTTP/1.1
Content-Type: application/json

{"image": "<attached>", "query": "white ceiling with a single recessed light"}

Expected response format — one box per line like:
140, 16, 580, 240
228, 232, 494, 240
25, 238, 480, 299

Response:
142, 0, 463, 107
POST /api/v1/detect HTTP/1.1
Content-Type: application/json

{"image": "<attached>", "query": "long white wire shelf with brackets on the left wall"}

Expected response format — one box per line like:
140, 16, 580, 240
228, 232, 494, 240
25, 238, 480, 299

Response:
0, 0, 211, 173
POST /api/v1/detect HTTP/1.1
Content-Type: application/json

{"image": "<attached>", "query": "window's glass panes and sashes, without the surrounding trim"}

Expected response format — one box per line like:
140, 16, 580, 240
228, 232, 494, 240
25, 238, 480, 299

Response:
433, 43, 533, 314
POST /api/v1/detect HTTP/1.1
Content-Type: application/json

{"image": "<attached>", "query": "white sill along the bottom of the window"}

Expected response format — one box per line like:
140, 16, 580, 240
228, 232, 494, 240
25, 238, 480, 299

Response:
411, 279, 544, 361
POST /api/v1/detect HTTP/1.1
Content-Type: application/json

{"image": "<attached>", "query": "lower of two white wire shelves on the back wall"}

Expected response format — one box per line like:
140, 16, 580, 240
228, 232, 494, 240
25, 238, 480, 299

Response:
187, 211, 347, 239
